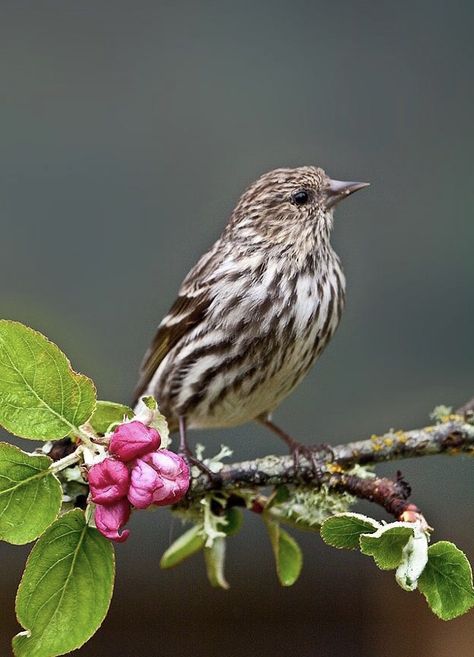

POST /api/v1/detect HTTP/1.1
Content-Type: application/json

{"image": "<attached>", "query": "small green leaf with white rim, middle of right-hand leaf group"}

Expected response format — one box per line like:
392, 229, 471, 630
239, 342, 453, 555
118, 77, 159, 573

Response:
360, 522, 415, 570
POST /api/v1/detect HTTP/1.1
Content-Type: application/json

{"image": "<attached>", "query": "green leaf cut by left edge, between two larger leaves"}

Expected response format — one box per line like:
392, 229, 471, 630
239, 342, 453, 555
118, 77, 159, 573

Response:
0, 443, 62, 545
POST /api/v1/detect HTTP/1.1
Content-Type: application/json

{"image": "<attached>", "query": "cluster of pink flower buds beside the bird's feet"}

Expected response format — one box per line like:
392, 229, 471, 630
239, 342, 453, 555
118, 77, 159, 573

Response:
88, 420, 190, 543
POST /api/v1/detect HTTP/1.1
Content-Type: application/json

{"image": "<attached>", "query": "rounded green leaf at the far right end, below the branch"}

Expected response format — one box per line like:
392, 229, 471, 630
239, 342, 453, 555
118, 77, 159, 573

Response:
418, 541, 474, 620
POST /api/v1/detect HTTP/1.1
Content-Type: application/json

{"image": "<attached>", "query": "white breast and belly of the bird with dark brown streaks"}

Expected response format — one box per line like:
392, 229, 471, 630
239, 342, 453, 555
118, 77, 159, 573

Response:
153, 254, 344, 427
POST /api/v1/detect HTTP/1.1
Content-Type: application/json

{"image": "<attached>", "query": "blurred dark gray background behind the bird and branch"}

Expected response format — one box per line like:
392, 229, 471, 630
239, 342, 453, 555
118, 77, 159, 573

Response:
0, 0, 474, 657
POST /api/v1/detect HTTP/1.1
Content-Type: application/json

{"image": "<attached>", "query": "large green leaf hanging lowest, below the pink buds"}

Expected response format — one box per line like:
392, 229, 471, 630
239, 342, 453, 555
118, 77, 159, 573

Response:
13, 509, 115, 657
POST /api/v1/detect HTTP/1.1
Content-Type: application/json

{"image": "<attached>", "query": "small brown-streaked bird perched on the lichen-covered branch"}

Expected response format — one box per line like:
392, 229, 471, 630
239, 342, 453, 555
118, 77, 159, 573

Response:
136, 166, 368, 450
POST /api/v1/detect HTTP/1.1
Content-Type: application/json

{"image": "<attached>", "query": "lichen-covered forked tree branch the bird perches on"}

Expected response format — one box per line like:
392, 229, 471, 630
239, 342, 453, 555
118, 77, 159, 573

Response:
188, 412, 474, 519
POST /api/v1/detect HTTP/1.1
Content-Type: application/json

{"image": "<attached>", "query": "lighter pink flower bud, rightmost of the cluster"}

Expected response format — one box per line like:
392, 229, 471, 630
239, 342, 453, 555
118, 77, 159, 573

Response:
128, 449, 189, 509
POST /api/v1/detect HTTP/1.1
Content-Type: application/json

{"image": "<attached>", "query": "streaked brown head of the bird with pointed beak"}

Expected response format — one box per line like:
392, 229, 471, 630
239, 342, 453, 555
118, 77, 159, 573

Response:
228, 166, 369, 245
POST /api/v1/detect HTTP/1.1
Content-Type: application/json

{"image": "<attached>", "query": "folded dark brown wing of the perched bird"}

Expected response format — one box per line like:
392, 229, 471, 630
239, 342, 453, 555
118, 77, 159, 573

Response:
134, 245, 222, 404
